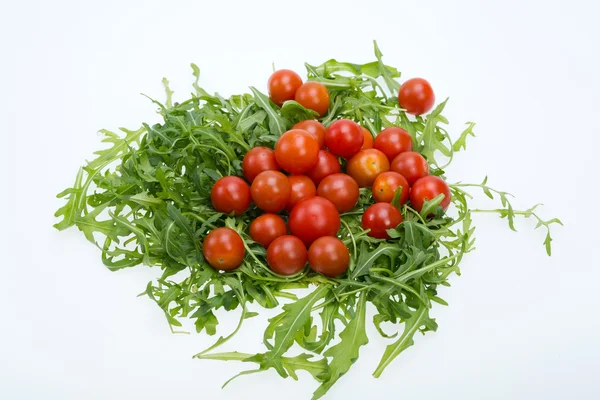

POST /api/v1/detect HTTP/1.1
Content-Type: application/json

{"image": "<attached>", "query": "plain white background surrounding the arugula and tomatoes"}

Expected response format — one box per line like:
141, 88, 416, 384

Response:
0, 0, 600, 400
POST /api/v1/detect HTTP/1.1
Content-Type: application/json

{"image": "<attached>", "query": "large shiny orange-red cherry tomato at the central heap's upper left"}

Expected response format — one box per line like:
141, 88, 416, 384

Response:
275, 129, 319, 174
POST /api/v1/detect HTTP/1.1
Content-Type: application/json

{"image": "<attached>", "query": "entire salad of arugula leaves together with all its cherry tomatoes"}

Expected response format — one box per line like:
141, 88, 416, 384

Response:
55, 43, 561, 399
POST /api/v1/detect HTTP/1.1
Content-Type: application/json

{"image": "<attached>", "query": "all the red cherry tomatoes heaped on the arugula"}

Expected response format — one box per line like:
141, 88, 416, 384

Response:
203, 69, 451, 277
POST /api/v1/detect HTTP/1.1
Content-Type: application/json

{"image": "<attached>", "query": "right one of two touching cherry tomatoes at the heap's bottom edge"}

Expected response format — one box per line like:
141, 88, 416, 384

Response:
308, 236, 350, 278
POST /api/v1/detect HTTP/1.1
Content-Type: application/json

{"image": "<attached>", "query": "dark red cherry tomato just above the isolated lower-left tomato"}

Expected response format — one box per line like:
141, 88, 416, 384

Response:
210, 176, 250, 215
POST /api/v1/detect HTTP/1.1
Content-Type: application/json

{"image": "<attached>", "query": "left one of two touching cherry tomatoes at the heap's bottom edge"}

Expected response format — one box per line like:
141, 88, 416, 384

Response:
267, 235, 306, 275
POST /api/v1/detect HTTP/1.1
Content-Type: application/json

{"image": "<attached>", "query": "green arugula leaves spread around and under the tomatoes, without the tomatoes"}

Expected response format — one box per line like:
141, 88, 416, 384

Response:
55, 43, 561, 399
